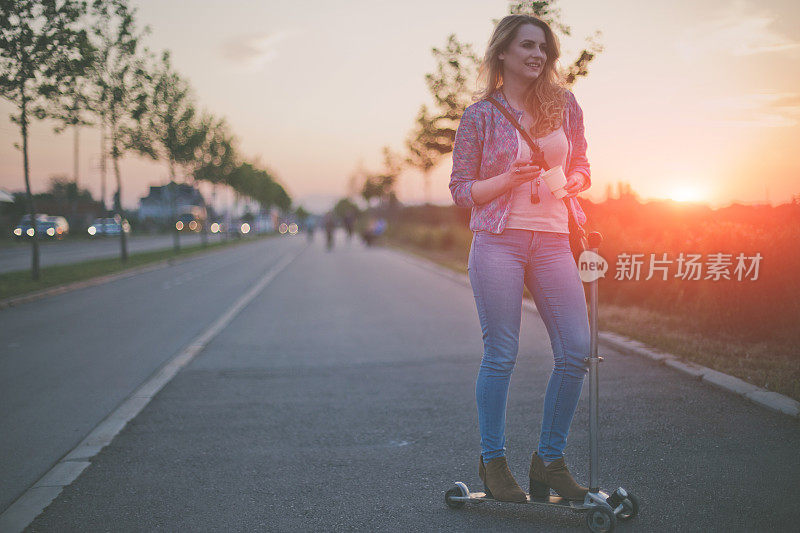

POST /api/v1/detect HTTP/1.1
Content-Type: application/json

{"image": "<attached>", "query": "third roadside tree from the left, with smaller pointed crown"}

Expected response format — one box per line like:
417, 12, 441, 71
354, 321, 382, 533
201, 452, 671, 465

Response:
130, 51, 197, 252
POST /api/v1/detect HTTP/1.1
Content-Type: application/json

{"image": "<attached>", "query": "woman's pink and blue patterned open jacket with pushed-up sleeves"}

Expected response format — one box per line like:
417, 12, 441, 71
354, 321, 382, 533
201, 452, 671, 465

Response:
450, 89, 591, 233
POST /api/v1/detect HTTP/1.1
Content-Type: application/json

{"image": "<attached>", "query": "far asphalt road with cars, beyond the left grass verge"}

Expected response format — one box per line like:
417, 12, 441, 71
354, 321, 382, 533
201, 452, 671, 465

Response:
0, 233, 222, 273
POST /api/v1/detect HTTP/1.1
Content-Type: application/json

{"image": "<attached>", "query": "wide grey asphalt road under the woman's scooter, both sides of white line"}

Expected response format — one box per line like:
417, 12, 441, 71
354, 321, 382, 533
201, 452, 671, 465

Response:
0, 231, 800, 532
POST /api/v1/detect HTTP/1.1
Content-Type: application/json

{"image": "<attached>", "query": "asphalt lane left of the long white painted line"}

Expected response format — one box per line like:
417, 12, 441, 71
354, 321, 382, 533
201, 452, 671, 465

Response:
0, 232, 296, 509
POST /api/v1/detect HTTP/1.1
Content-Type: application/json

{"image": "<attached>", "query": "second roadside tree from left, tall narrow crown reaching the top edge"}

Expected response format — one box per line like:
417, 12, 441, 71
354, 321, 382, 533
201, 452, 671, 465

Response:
86, 0, 149, 263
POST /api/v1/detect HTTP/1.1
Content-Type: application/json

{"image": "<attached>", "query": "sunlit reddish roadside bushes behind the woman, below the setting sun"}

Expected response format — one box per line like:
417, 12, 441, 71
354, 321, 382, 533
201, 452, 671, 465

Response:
389, 198, 800, 345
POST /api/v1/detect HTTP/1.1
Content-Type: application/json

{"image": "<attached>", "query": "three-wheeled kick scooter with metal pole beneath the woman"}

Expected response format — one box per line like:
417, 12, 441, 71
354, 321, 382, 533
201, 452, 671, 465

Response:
444, 231, 639, 533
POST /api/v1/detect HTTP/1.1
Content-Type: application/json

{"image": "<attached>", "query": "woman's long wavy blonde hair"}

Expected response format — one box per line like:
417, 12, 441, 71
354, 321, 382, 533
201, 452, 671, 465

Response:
475, 15, 567, 137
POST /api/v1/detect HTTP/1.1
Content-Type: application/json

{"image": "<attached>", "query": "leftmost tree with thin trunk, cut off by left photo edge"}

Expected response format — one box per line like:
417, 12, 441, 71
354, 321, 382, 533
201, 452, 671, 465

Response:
0, 0, 86, 280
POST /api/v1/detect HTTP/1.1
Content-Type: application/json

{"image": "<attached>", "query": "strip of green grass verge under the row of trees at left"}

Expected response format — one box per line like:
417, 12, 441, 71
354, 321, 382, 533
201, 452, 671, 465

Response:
0, 234, 272, 300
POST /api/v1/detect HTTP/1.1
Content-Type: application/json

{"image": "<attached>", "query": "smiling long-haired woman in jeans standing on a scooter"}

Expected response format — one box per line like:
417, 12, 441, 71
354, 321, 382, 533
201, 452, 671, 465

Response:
450, 15, 590, 501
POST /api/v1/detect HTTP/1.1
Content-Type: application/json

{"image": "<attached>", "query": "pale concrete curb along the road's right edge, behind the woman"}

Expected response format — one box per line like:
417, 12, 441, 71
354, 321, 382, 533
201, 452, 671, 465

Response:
389, 244, 800, 419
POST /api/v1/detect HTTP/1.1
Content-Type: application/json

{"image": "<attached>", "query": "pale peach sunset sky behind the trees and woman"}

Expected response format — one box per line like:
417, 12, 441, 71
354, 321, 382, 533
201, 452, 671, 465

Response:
0, 0, 800, 211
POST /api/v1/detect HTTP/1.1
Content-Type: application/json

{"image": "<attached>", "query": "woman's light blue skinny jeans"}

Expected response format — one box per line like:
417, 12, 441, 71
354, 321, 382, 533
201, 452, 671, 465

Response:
469, 229, 590, 461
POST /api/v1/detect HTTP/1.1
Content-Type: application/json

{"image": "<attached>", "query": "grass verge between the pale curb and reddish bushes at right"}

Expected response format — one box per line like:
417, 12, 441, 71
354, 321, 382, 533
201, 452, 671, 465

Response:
386, 240, 800, 401
